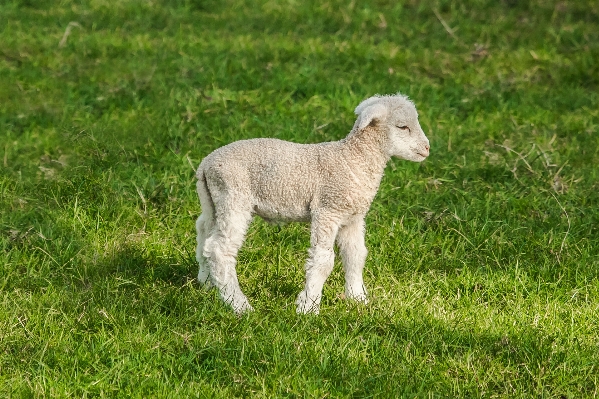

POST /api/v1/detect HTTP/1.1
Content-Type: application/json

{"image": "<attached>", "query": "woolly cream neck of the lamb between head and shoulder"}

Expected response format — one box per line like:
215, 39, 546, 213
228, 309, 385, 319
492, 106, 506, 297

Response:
342, 127, 390, 187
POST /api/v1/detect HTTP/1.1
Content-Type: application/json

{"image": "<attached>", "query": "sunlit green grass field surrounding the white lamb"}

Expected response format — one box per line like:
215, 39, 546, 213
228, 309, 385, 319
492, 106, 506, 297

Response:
0, 0, 599, 398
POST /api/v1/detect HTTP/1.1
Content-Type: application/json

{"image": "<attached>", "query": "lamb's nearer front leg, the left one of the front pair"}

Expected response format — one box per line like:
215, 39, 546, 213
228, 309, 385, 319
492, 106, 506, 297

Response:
295, 214, 339, 314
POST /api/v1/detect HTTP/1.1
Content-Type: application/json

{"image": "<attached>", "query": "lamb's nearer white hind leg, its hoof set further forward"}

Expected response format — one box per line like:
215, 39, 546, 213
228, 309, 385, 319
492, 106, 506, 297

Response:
203, 206, 253, 314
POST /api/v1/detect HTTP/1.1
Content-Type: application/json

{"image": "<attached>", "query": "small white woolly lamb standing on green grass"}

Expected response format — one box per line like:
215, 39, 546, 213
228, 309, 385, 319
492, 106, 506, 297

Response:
196, 93, 430, 314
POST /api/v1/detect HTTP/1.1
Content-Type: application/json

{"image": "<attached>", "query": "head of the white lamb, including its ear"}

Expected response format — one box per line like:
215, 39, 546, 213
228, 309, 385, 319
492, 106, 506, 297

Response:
355, 93, 430, 162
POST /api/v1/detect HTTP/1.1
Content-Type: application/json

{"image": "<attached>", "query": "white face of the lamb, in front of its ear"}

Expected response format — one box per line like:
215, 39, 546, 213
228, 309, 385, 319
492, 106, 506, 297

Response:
385, 103, 430, 162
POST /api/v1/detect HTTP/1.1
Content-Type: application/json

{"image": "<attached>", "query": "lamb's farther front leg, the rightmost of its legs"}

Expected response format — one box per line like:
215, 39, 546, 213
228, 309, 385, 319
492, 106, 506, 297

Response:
337, 216, 368, 303
